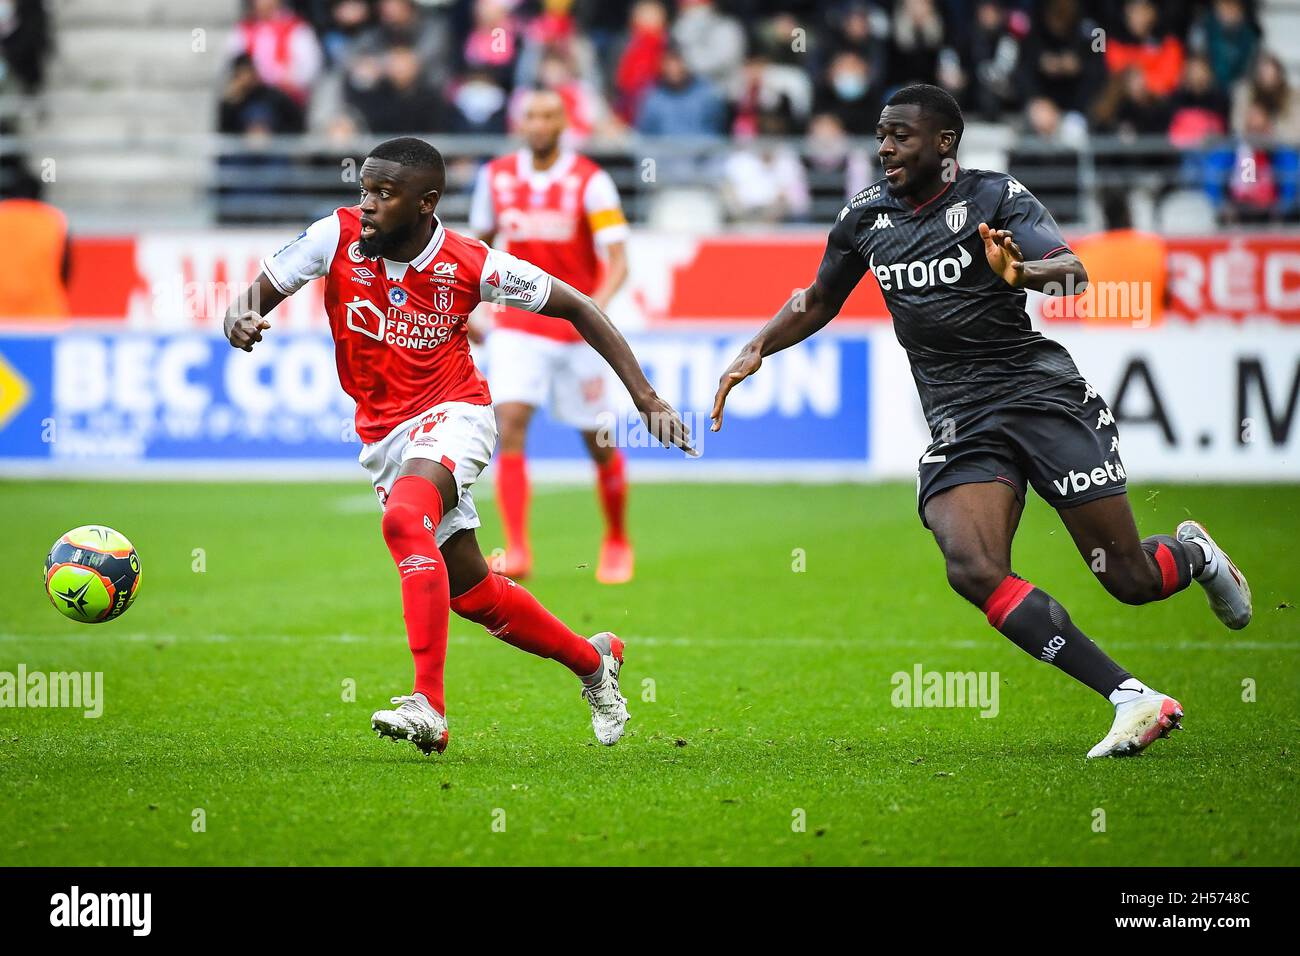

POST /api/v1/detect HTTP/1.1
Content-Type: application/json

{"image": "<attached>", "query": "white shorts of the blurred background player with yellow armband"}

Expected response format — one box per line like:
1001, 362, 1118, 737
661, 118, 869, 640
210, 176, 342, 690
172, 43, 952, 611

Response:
488, 329, 610, 432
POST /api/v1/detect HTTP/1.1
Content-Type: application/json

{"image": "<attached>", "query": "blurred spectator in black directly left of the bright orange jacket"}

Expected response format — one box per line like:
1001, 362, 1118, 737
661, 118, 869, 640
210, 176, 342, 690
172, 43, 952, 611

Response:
1022, 0, 1105, 116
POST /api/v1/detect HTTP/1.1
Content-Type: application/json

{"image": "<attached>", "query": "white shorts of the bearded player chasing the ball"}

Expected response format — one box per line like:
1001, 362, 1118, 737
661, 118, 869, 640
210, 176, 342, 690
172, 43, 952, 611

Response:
358, 402, 497, 548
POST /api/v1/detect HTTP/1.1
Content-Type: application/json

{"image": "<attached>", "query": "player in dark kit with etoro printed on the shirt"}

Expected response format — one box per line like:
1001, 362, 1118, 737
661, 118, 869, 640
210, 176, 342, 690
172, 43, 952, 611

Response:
712, 85, 1251, 757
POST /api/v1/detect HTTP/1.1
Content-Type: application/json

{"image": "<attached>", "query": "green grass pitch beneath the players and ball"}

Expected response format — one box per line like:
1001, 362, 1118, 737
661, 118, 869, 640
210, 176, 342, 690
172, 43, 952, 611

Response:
0, 480, 1300, 866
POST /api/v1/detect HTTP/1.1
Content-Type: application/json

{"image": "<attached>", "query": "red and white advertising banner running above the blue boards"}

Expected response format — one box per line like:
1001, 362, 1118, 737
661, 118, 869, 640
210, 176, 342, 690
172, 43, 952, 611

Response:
40, 232, 1300, 328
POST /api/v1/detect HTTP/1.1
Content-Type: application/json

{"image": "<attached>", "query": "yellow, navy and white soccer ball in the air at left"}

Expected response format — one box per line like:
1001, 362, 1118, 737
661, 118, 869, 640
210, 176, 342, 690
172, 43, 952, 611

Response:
46, 524, 140, 624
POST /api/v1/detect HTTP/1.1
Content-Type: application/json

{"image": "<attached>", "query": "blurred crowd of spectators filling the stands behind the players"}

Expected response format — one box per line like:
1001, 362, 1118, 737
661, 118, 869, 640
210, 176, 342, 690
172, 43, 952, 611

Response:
0, 0, 1300, 222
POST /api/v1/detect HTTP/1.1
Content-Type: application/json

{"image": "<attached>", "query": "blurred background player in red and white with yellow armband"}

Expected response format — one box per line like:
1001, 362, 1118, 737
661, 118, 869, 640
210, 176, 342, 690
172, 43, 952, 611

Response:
469, 90, 632, 584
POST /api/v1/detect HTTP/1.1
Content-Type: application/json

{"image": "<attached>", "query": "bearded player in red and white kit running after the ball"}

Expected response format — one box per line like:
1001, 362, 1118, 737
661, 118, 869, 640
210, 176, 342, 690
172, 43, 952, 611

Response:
225, 138, 690, 753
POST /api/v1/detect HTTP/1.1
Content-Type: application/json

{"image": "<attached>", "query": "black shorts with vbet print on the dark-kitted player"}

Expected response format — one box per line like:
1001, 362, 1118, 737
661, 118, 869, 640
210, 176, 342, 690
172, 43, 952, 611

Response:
917, 378, 1126, 528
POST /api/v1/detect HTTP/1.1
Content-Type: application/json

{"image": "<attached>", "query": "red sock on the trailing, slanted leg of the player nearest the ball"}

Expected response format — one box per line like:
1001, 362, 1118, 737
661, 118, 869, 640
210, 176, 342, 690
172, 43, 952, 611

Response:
451, 571, 601, 678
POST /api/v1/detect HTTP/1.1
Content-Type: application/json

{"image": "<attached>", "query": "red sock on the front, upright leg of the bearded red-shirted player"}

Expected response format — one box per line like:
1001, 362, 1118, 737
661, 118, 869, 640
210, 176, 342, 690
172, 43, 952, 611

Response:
384, 475, 451, 715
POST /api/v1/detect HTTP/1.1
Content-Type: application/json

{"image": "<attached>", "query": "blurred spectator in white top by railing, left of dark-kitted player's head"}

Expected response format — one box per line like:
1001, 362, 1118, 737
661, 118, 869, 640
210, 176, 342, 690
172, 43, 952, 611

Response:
722, 109, 811, 225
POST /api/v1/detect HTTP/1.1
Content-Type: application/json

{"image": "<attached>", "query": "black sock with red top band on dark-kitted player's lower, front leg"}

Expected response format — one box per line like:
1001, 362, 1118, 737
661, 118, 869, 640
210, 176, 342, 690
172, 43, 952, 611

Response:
984, 575, 1132, 698
